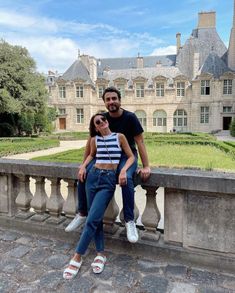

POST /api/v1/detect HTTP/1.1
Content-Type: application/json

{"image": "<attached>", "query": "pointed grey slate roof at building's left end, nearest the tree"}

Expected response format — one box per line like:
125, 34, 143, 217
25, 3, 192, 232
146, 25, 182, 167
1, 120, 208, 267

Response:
59, 60, 93, 84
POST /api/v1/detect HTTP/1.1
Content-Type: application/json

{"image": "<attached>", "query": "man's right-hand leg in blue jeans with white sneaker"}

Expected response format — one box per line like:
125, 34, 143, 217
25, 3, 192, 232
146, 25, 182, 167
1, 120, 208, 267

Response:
118, 155, 138, 243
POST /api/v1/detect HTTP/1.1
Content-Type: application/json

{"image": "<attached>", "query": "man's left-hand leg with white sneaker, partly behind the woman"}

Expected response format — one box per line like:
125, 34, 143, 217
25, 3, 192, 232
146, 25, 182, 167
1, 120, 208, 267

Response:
65, 160, 95, 232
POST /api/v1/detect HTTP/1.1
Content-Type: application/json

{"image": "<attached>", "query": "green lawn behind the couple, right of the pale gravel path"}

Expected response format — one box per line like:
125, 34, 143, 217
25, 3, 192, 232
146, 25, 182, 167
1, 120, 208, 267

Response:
31, 143, 235, 172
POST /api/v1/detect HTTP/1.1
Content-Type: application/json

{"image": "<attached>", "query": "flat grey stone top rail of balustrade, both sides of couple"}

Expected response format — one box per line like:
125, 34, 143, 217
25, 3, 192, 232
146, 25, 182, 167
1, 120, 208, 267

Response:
0, 159, 235, 195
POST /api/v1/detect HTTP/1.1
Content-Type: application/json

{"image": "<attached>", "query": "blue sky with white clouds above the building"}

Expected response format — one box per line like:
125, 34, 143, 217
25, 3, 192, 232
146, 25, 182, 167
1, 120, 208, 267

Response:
0, 0, 233, 73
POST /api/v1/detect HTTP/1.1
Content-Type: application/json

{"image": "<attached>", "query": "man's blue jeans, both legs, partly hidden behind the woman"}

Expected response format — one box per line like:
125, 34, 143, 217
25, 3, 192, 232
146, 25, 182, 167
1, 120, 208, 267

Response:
78, 153, 138, 222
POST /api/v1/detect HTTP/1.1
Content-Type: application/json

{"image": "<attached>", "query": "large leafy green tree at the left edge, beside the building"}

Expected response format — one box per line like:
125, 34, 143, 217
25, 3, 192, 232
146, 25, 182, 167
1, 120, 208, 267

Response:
0, 40, 48, 134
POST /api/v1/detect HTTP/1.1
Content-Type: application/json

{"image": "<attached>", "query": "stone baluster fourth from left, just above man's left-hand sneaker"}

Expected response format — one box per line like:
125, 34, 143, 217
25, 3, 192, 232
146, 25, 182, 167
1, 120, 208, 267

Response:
63, 179, 78, 218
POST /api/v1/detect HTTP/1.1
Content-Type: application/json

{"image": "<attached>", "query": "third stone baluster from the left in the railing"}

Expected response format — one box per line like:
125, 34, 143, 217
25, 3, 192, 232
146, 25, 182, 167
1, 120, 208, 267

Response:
46, 178, 64, 217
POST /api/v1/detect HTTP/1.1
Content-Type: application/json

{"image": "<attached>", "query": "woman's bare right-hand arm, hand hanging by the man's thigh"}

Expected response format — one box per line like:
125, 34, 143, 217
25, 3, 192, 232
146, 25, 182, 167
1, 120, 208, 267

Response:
118, 133, 135, 185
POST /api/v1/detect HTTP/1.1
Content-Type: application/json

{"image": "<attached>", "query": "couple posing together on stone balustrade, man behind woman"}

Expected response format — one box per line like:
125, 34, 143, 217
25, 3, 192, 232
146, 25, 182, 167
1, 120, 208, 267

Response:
63, 87, 150, 279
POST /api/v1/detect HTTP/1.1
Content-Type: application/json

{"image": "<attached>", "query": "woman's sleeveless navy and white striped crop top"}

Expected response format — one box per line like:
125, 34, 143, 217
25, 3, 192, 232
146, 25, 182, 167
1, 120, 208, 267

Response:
95, 133, 122, 164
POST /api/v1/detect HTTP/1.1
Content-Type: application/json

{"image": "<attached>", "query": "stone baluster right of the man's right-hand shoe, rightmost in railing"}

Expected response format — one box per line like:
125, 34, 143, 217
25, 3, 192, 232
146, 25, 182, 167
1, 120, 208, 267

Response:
141, 185, 161, 241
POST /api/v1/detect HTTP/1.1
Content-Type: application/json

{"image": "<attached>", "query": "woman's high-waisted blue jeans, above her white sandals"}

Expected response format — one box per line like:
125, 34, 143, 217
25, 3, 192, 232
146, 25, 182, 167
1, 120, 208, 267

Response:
76, 167, 116, 255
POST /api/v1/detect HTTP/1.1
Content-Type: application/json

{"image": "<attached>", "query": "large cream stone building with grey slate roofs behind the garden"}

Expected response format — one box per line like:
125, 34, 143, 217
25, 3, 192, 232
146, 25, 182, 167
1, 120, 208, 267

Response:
48, 1, 235, 132
